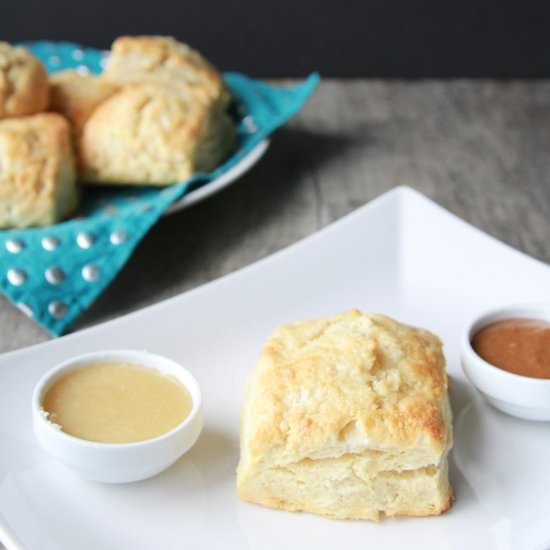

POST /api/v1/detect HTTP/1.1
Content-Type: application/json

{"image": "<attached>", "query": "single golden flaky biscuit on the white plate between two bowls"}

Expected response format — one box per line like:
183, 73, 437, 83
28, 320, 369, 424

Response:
237, 310, 452, 520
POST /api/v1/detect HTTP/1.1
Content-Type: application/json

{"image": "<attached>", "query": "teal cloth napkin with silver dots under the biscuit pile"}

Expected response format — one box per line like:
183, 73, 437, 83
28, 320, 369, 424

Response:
0, 42, 319, 335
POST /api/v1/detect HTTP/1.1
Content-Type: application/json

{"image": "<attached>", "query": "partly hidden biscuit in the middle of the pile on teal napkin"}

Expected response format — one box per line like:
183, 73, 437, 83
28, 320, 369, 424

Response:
49, 69, 119, 136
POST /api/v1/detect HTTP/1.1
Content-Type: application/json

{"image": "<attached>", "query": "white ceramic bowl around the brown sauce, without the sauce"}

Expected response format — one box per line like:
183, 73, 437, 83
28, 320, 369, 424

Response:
461, 305, 550, 420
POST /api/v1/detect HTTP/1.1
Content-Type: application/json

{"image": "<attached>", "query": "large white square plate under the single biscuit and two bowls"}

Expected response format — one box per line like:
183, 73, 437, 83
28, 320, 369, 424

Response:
0, 188, 550, 550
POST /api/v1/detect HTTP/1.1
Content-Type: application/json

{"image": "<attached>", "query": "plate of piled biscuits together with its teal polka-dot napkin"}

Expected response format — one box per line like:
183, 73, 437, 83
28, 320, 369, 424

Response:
0, 36, 319, 334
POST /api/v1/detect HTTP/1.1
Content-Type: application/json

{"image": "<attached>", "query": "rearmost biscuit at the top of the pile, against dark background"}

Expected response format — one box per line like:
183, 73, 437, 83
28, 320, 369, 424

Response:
103, 36, 230, 107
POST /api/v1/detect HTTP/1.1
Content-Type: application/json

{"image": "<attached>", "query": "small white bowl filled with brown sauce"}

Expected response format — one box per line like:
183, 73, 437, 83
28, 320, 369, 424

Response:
461, 305, 550, 420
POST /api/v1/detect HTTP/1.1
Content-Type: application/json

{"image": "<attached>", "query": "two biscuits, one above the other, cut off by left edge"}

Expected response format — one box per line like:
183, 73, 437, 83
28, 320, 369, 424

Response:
0, 42, 78, 227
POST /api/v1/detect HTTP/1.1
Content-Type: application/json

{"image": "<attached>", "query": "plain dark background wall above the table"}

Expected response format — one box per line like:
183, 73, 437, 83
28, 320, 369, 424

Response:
0, 0, 550, 77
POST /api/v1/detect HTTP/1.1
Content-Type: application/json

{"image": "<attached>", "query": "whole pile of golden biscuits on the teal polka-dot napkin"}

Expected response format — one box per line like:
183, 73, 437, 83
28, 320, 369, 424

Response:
0, 36, 236, 227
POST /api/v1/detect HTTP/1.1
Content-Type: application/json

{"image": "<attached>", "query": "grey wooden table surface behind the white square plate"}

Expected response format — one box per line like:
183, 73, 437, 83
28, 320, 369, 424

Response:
0, 80, 550, 352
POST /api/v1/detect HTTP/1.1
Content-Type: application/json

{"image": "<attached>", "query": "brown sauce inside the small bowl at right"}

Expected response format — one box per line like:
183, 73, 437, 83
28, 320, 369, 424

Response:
472, 319, 550, 379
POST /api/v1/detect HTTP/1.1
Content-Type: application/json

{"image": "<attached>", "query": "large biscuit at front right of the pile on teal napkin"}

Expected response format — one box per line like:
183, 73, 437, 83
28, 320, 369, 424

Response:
79, 84, 235, 185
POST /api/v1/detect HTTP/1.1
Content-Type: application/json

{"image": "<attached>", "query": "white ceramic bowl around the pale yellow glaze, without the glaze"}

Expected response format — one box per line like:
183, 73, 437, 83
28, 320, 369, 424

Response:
32, 350, 203, 483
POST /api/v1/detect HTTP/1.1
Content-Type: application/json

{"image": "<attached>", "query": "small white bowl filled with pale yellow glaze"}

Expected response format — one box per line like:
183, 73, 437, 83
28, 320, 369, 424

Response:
32, 350, 203, 483
